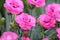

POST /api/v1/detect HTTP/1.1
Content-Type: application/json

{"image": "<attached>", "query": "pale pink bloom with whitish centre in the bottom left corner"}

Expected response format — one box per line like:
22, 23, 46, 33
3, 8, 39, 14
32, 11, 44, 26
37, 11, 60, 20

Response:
1, 32, 18, 40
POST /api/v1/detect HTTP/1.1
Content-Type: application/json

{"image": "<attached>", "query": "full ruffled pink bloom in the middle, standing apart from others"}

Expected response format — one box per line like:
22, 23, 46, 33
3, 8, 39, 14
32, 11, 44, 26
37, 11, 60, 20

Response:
15, 13, 36, 30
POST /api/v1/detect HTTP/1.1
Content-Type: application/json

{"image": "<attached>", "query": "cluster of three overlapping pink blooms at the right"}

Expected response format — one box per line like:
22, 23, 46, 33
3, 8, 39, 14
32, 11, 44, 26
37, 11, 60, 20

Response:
38, 3, 60, 29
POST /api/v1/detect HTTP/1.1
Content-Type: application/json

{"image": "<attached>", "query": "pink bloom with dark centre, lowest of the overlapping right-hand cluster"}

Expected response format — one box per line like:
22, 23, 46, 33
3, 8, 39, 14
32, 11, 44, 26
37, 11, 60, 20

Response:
38, 14, 55, 29
